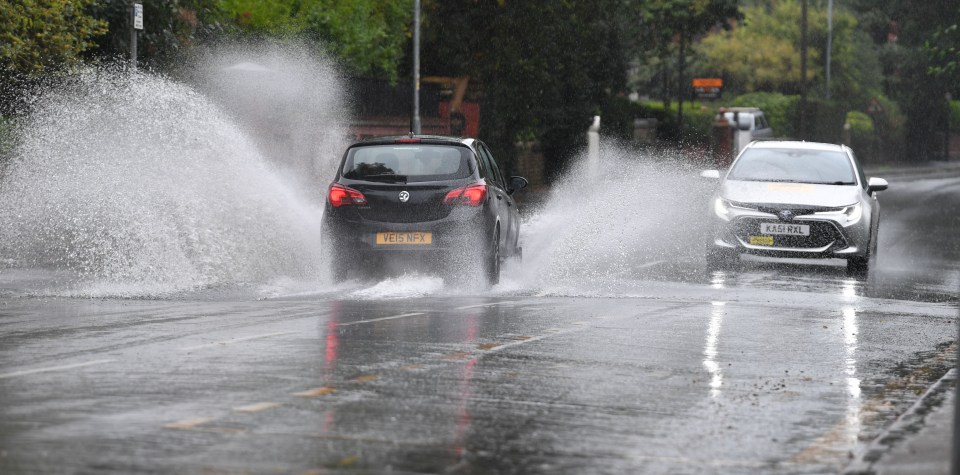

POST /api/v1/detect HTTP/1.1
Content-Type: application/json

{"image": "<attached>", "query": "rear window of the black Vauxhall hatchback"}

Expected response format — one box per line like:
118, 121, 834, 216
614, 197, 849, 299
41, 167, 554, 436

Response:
341, 144, 473, 183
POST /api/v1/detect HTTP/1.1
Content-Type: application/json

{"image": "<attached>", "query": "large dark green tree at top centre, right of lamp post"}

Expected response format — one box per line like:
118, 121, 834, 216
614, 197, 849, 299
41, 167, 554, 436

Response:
423, 0, 629, 177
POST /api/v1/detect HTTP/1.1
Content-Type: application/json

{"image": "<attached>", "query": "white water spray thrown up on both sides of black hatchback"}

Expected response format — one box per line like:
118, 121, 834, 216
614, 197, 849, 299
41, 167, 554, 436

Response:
0, 41, 709, 299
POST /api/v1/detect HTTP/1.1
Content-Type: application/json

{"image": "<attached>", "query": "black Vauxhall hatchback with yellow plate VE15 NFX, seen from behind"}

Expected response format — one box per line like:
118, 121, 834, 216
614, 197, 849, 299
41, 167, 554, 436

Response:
323, 135, 527, 285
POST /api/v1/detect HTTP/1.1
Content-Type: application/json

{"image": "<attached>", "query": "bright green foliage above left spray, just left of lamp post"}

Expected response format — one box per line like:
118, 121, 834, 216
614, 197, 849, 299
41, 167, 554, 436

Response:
222, 0, 413, 81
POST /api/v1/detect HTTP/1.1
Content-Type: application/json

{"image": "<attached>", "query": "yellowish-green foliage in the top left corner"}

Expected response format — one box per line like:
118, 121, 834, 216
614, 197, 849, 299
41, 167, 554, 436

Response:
0, 0, 106, 74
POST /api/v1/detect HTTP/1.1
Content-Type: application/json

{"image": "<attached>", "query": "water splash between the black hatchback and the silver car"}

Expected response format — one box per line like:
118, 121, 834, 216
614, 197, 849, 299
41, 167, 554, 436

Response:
502, 141, 715, 295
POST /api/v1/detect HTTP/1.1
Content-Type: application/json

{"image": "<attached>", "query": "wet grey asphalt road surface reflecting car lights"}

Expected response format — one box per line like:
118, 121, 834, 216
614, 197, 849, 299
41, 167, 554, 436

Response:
0, 173, 960, 474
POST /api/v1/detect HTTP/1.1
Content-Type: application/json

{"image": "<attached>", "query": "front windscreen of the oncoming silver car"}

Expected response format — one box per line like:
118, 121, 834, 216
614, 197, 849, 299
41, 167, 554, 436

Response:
727, 148, 857, 185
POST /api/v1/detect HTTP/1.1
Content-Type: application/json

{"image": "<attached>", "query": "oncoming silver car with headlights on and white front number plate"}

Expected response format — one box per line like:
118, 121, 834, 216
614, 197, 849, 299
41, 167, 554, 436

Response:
701, 141, 887, 275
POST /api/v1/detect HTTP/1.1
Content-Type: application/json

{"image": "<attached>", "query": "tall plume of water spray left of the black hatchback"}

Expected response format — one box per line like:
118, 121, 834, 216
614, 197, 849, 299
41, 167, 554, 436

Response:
0, 45, 343, 296
